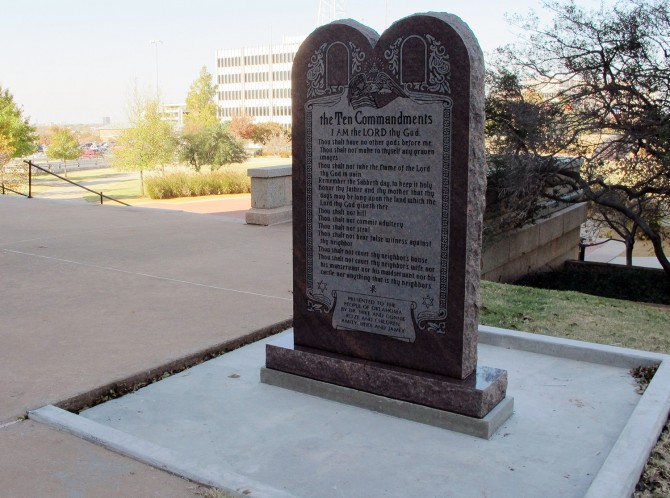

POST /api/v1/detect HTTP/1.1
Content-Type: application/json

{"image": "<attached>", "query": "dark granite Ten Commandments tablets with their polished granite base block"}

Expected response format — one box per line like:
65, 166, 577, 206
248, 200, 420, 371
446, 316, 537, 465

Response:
264, 13, 511, 436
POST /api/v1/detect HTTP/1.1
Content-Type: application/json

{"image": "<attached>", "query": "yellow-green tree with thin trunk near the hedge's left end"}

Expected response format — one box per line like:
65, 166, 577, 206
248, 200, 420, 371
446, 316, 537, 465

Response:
112, 98, 176, 195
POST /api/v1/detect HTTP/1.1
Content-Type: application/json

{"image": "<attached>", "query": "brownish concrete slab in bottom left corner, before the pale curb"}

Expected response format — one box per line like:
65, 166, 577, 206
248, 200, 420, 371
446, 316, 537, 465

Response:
0, 420, 201, 498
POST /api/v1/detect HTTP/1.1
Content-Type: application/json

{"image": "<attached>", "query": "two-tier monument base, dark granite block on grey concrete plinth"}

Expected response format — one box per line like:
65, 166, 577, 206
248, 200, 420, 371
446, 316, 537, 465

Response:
261, 336, 513, 438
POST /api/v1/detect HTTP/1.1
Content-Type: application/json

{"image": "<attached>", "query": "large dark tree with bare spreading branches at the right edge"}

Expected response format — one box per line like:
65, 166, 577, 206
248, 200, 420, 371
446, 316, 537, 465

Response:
493, 0, 670, 276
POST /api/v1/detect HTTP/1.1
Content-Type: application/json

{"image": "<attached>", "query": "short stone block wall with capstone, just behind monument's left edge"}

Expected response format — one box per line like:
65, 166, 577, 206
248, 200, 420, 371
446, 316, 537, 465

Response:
245, 164, 293, 226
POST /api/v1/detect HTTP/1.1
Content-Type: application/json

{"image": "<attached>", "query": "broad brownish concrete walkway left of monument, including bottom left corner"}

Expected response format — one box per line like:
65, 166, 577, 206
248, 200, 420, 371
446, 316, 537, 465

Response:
0, 196, 292, 497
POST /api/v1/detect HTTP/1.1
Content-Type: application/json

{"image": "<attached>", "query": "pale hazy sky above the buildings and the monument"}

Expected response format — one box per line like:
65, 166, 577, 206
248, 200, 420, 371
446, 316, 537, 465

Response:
0, 0, 608, 125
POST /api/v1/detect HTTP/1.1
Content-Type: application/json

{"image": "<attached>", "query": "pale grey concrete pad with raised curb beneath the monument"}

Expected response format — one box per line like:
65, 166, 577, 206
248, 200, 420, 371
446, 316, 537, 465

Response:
32, 327, 670, 498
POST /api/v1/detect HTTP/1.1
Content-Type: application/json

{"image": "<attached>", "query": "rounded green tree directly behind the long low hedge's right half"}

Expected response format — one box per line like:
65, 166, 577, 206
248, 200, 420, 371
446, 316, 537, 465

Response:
179, 124, 246, 172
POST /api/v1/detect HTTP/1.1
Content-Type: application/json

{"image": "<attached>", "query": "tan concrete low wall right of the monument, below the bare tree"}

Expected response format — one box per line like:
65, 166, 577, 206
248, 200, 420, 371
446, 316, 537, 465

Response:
482, 203, 587, 282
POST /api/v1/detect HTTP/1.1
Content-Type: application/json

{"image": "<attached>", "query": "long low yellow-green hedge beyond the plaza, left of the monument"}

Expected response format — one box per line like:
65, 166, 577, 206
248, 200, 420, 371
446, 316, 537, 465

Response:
144, 170, 251, 199
